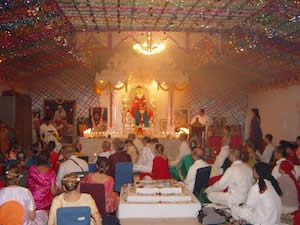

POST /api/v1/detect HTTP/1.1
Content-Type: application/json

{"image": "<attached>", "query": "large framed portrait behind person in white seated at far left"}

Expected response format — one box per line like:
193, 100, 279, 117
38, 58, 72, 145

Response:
44, 99, 76, 144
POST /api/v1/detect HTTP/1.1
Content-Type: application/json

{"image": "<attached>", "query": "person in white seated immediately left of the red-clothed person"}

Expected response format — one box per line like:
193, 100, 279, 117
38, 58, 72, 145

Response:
133, 137, 154, 173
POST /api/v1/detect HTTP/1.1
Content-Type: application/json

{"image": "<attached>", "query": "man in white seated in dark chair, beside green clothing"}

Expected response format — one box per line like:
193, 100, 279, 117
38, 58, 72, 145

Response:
184, 148, 209, 192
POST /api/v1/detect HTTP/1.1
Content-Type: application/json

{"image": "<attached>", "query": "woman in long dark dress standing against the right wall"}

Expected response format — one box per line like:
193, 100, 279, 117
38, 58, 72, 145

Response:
249, 108, 264, 154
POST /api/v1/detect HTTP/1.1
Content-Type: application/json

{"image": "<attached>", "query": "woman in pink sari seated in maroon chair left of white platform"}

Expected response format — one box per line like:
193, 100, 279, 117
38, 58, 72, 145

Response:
81, 157, 119, 213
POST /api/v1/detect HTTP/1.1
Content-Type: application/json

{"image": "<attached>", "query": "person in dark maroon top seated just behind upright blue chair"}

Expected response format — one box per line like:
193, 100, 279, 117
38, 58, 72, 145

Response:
108, 138, 131, 178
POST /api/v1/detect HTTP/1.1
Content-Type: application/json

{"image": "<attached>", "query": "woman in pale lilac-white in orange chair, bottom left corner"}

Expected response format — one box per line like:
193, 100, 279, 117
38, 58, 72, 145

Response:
0, 164, 48, 225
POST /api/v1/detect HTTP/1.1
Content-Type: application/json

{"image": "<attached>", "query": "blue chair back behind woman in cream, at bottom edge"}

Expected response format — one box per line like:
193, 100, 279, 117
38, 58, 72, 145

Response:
56, 206, 91, 225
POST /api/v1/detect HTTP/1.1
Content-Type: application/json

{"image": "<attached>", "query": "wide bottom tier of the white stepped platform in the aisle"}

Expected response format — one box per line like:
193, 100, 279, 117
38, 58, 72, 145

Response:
118, 185, 201, 219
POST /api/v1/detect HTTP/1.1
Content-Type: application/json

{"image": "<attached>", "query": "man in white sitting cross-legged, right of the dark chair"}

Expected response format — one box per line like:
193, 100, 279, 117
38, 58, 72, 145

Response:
205, 149, 253, 207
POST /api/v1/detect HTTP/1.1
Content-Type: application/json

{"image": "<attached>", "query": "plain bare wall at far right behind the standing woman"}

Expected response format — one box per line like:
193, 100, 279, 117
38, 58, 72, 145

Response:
247, 86, 300, 144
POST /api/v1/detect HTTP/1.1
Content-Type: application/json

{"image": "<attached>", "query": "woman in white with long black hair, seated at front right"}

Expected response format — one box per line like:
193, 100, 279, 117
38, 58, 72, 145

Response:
231, 162, 282, 225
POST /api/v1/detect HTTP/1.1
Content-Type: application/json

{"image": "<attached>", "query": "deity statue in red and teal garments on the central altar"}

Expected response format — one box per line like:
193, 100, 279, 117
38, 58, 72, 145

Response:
130, 86, 152, 127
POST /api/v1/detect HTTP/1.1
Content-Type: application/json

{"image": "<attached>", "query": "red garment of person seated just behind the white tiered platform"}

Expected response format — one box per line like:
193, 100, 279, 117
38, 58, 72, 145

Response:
140, 156, 172, 180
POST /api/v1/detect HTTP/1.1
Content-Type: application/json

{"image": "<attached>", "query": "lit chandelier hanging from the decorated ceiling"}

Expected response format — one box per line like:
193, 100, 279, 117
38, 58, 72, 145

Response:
133, 32, 166, 55
